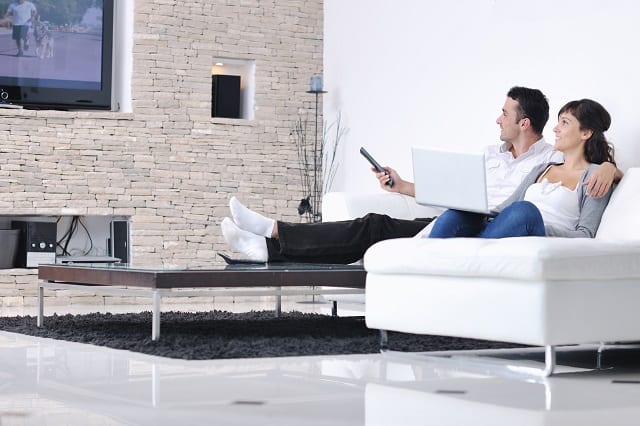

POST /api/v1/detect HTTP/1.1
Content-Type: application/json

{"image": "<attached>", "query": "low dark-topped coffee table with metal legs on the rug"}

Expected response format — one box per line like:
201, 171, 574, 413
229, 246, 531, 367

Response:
37, 263, 366, 340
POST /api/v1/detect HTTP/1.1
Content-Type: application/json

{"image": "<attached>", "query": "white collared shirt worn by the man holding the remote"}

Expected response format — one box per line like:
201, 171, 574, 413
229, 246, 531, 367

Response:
485, 139, 563, 209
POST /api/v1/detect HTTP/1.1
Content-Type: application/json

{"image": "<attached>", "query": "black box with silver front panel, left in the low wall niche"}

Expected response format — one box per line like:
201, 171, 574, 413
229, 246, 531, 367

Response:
11, 221, 58, 268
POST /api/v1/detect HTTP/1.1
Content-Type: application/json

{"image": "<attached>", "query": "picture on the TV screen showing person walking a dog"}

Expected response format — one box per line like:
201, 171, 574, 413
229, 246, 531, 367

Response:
0, 0, 104, 90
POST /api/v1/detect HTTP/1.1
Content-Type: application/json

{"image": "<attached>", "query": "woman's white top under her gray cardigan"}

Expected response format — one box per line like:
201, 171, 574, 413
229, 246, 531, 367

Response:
524, 178, 580, 230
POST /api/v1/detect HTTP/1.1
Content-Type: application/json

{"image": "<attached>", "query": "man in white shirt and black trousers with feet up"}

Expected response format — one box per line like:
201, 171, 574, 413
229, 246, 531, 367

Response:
221, 87, 622, 263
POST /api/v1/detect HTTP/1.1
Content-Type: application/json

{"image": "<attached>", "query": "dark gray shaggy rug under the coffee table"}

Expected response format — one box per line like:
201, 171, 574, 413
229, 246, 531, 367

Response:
0, 311, 519, 359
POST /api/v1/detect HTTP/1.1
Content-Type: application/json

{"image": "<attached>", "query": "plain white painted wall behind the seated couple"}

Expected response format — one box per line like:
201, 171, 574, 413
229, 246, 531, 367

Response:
324, 0, 640, 192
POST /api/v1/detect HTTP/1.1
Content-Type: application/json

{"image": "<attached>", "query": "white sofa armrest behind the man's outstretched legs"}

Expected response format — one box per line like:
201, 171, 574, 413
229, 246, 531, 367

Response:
322, 192, 442, 222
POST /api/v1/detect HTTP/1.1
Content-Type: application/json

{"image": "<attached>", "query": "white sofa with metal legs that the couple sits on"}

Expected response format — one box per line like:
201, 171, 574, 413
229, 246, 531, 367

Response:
325, 169, 640, 374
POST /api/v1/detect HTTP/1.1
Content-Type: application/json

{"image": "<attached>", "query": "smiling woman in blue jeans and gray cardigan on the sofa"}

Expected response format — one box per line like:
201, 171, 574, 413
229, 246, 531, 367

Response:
429, 99, 615, 238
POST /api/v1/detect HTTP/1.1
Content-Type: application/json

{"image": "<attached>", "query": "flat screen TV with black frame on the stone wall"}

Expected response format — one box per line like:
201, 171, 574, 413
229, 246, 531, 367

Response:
0, 0, 115, 110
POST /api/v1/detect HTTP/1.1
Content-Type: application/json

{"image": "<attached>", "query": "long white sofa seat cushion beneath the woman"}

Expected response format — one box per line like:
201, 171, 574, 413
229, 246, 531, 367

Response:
364, 237, 640, 285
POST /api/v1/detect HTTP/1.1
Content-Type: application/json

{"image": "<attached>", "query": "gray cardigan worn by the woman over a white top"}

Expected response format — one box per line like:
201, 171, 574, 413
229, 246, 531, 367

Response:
494, 163, 613, 238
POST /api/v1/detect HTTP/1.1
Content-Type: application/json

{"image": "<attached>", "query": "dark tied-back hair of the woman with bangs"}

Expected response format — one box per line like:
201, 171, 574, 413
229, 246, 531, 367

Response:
558, 99, 616, 165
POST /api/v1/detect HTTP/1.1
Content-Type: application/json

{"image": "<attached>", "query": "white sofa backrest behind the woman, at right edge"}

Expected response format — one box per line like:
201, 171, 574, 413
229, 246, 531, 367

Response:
596, 167, 640, 241
